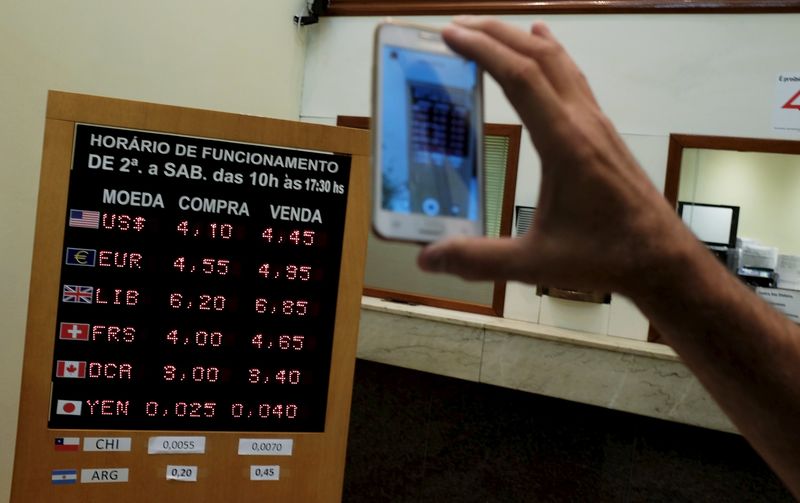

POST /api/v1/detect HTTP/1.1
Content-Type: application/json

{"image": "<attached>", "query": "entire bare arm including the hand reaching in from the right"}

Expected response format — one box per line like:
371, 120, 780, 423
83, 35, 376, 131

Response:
419, 17, 800, 497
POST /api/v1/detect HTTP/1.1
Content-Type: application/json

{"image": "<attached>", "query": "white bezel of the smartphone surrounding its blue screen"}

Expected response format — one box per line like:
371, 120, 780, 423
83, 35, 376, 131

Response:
371, 21, 486, 243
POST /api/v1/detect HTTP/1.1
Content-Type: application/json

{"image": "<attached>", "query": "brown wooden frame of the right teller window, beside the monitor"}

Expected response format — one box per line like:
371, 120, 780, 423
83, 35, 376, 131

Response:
647, 134, 800, 343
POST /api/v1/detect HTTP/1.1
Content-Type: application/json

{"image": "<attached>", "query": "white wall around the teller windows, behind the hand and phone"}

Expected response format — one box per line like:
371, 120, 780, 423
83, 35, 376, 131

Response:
301, 14, 800, 339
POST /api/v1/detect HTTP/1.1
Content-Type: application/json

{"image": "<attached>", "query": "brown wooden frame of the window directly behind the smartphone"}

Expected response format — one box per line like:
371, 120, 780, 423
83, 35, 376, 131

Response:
336, 115, 522, 317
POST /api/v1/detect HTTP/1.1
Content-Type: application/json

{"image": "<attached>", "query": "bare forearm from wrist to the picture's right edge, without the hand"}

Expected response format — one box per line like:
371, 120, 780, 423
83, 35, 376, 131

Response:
633, 239, 800, 497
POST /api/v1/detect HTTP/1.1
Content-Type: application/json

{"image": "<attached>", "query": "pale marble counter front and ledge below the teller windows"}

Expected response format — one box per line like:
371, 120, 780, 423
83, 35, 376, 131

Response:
358, 297, 736, 432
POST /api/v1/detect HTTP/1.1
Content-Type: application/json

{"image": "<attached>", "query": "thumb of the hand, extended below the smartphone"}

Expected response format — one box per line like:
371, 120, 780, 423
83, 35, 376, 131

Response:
417, 237, 530, 280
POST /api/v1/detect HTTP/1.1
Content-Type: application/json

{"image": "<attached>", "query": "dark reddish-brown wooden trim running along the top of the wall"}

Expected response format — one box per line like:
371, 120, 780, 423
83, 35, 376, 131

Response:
325, 0, 800, 16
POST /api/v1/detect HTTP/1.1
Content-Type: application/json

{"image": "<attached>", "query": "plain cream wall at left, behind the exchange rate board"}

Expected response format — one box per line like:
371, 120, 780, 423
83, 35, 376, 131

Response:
0, 0, 306, 500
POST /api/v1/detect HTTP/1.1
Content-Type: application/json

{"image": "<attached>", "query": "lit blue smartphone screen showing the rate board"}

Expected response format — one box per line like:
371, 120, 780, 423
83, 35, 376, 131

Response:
375, 28, 482, 243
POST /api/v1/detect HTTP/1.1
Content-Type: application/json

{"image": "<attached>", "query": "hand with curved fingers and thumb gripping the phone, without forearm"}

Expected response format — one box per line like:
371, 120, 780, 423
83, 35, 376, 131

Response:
418, 16, 695, 293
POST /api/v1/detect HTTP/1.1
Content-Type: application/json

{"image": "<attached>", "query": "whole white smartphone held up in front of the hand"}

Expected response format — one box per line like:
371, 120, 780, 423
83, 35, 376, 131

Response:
372, 22, 485, 243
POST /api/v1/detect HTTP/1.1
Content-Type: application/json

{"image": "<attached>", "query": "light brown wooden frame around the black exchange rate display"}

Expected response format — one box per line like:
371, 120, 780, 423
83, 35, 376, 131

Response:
11, 92, 369, 502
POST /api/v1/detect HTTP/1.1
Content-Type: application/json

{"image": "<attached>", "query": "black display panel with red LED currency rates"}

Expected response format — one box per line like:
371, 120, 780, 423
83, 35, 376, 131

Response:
48, 124, 350, 432
